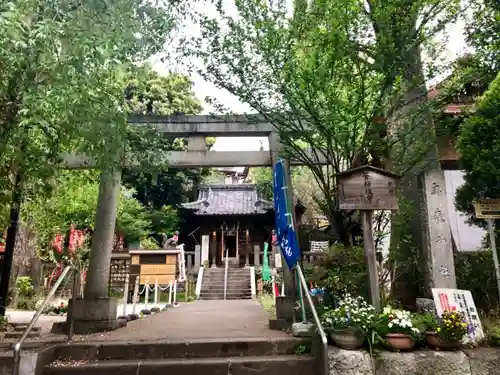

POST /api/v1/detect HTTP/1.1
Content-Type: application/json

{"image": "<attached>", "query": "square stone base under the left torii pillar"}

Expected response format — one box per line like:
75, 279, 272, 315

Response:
58, 298, 118, 335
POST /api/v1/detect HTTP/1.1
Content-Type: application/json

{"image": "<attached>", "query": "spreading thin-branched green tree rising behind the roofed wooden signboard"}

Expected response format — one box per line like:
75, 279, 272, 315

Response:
190, 0, 456, 245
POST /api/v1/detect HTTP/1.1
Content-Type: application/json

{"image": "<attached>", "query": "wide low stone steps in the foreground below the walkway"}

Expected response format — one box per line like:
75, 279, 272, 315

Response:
42, 337, 319, 375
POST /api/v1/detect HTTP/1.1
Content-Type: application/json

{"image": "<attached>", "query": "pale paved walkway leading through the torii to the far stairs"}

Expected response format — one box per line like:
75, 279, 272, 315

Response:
86, 300, 289, 341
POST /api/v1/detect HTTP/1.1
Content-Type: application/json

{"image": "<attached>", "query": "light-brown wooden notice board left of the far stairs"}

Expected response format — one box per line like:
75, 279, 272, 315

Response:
130, 250, 179, 285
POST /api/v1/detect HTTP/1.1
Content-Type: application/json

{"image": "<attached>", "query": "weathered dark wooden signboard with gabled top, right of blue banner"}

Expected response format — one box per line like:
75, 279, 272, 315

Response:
336, 165, 399, 211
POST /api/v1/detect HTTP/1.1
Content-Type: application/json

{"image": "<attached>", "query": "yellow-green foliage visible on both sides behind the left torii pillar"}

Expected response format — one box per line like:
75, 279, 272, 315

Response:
23, 171, 179, 259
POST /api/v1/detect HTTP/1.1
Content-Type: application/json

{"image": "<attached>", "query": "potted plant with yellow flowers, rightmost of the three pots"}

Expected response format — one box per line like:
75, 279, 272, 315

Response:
425, 311, 468, 350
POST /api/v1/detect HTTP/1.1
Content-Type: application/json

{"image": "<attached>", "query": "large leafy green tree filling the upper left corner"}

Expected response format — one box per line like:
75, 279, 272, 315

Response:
0, 0, 177, 315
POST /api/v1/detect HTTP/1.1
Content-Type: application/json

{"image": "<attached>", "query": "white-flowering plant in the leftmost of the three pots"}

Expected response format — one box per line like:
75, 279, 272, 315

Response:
322, 294, 375, 333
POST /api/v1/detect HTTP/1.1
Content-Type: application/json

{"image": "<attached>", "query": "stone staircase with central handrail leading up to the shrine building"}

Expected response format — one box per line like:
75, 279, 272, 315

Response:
200, 265, 252, 300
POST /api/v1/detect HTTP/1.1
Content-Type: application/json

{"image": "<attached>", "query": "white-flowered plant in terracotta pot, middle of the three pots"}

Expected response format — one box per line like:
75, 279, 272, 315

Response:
375, 307, 420, 350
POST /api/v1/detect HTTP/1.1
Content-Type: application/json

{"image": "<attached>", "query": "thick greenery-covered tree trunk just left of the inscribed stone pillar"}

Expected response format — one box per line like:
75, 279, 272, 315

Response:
390, 48, 438, 307
